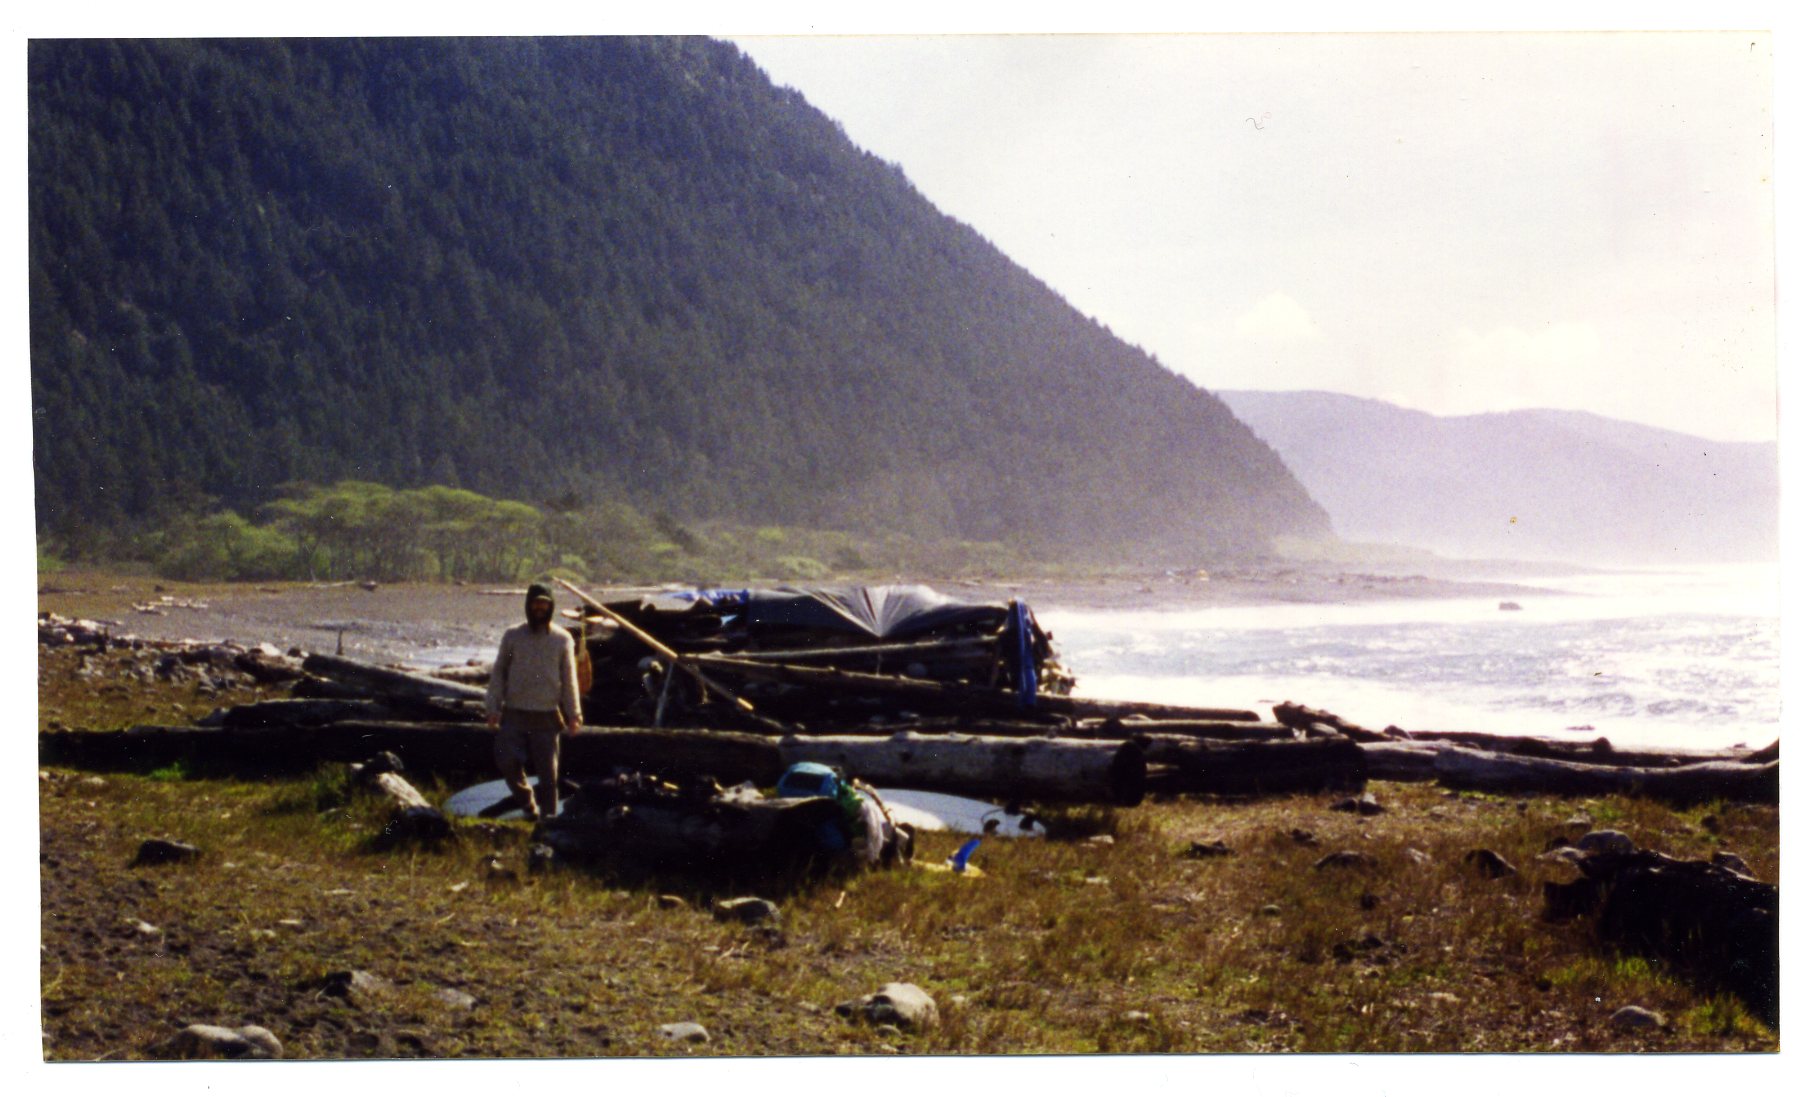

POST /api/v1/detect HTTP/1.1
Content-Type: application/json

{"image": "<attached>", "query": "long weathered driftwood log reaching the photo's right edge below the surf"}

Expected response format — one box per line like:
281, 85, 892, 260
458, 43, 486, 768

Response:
1434, 746, 1779, 803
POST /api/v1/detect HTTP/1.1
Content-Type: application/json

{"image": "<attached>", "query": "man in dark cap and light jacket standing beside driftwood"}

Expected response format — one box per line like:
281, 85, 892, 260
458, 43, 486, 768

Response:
485, 583, 579, 819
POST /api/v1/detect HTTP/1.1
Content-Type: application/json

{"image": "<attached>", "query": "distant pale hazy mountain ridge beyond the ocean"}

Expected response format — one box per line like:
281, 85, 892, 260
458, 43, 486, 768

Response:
1221, 392, 1777, 563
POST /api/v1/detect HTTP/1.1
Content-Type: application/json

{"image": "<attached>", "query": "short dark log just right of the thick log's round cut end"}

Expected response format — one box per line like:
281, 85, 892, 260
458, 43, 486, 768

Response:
1145, 736, 1367, 796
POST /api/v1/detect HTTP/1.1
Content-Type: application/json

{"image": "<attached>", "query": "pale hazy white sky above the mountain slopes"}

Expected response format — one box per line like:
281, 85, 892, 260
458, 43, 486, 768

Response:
735, 33, 1777, 440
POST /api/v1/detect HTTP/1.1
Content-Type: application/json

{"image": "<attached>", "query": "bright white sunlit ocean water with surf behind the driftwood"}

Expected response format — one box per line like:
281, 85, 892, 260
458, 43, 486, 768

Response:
1036, 565, 1782, 746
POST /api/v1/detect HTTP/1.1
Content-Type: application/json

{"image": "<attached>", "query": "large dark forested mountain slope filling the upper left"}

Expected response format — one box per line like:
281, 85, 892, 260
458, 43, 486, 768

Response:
27, 38, 1329, 559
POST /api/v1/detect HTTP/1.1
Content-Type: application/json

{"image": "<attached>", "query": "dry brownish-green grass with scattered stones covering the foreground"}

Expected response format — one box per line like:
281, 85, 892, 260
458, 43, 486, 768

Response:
40, 759, 1777, 1059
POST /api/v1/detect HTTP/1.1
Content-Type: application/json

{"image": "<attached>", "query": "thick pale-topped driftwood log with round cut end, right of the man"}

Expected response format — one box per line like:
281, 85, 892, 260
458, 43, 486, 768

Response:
780, 734, 1147, 805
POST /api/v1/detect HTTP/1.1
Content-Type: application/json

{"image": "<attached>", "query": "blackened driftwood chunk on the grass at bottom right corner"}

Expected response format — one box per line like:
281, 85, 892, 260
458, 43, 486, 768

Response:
1545, 850, 1781, 1026
